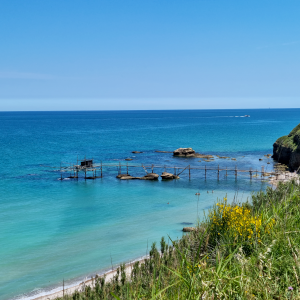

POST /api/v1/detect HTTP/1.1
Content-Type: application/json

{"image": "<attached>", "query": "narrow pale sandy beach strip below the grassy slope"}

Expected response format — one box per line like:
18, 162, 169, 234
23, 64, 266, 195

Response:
26, 255, 149, 300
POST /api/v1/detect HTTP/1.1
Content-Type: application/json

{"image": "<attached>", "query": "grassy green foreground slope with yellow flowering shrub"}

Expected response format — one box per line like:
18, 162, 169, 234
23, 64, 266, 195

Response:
57, 182, 300, 300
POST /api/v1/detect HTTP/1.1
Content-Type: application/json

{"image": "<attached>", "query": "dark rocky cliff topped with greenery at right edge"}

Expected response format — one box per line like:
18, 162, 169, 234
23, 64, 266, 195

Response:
272, 124, 300, 170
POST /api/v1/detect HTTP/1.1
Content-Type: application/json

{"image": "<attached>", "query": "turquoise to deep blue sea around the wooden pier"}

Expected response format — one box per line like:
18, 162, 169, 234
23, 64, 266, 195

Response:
0, 109, 300, 299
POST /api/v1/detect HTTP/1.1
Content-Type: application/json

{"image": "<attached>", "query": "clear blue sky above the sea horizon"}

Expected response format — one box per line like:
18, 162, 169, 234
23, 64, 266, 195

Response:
0, 0, 300, 110
